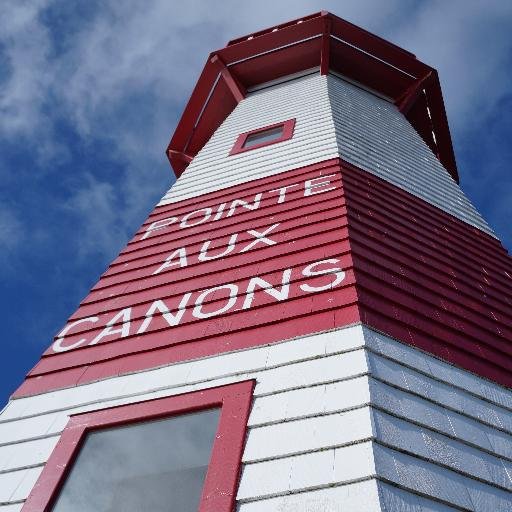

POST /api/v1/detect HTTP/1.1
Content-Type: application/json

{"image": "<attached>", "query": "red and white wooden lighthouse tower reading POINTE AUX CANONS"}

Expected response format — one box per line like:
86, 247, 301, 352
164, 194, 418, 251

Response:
0, 12, 512, 512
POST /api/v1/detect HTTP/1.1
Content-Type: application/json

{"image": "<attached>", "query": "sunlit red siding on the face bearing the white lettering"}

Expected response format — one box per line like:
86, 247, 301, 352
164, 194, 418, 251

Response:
16, 161, 359, 396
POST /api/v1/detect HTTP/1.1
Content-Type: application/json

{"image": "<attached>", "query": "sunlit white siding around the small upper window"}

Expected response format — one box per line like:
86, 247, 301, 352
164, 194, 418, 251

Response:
159, 71, 338, 204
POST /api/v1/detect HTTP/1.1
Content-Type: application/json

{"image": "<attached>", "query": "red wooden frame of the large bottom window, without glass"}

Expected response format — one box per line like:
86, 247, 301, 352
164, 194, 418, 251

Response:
22, 380, 255, 512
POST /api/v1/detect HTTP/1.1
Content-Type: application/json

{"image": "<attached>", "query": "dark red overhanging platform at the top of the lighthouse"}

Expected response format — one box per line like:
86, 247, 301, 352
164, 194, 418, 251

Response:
167, 11, 458, 182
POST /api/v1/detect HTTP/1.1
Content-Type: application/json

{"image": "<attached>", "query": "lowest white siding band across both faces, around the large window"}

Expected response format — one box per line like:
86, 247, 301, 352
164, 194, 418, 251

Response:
0, 326, 512, 512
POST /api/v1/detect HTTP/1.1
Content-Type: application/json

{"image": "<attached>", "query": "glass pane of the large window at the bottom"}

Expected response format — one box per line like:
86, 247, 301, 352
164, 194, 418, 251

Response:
53, 409, 220, 512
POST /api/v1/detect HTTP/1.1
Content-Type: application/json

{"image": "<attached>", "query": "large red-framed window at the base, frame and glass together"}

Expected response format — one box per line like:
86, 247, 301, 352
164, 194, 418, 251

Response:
23, 381, 253, 512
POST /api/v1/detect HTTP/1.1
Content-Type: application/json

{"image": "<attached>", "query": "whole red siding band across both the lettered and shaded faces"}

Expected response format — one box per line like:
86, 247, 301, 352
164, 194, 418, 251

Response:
16, 160, 512, 396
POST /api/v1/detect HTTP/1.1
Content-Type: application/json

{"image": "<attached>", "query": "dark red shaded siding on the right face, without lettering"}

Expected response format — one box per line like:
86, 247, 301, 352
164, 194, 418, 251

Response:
342, 162, 512, 386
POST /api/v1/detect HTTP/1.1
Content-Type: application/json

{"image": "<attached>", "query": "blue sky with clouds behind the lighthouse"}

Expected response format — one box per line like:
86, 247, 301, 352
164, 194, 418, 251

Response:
0, 0, 512, 406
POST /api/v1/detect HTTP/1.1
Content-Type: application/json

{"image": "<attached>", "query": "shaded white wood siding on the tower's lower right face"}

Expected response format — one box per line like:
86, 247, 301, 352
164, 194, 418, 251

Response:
364, 328, 512, 512
